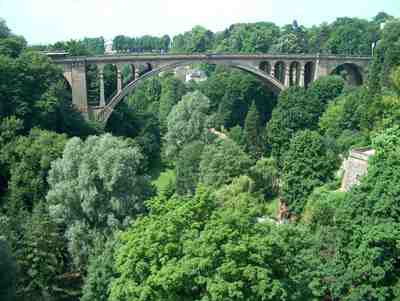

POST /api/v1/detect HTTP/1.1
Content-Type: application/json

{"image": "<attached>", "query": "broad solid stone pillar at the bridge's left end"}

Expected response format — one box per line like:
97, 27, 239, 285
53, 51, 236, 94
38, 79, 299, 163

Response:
71, 61, 88, 118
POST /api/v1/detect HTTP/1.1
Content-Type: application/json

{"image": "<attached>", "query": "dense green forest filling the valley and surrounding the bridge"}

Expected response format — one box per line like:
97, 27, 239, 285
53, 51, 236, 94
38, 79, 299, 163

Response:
0, 13, 400, 301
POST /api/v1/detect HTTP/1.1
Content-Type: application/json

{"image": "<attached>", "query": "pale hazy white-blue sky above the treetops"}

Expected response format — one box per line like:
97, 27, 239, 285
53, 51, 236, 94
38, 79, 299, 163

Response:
0, 0, 400, 44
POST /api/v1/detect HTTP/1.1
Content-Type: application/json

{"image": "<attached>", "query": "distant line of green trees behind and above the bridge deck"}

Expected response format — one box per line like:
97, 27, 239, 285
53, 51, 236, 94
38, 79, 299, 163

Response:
33, 12, 393, 55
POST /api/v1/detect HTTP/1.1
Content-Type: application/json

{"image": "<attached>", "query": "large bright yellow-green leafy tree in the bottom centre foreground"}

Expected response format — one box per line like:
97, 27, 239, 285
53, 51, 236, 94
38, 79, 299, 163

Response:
110, 189, 312, 301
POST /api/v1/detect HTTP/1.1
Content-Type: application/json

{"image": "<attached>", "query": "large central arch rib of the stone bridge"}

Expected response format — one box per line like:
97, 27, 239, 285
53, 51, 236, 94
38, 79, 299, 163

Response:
92, 60, 285, 124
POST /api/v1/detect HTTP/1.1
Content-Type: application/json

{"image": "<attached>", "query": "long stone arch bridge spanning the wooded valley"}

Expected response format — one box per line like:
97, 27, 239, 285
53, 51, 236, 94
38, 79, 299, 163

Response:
50, 54, 371, 123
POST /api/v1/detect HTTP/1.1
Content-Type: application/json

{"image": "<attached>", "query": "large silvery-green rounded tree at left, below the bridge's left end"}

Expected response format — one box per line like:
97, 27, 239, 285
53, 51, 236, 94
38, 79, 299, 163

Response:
46, 134, 152, 270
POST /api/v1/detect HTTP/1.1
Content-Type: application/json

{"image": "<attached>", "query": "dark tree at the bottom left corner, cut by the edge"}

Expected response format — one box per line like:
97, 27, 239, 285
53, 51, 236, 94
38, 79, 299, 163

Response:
0, 237, 17, 301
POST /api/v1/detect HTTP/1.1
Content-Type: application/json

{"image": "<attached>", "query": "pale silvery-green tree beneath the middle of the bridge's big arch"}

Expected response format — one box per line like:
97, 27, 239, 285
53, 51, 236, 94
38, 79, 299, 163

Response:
165, 91, 210, 157
